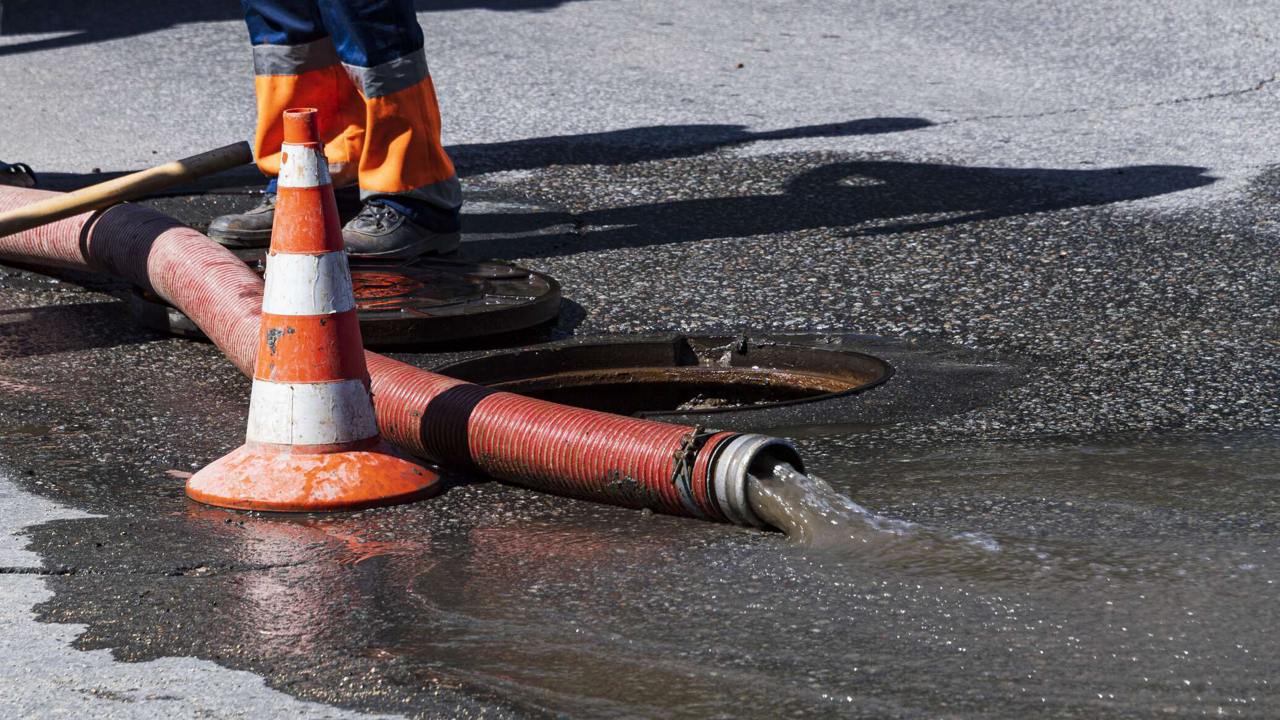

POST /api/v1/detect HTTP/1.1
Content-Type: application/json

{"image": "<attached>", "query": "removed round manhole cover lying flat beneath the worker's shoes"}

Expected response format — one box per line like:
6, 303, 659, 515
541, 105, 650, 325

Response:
131, 251, 561, 347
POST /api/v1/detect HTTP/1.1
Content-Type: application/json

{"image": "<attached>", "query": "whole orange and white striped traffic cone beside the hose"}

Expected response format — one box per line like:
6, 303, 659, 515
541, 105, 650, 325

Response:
187, 109, 439, 512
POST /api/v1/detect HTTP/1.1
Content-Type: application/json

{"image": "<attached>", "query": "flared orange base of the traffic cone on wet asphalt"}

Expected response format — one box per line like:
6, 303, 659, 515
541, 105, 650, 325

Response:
187, 443, 440, 512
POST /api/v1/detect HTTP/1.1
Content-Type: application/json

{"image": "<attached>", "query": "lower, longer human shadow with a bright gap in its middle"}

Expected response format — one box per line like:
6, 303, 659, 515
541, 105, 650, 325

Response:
466, 154, 1215, 258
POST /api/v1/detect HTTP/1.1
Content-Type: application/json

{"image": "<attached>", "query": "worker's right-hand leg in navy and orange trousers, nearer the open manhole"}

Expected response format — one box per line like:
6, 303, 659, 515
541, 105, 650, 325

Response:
317, 0, 462, 242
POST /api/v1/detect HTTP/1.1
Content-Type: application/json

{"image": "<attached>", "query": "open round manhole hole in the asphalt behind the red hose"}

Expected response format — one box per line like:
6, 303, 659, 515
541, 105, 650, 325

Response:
439, 336, 892, 416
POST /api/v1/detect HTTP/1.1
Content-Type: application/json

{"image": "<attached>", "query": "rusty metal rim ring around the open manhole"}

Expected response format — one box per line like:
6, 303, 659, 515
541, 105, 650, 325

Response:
434, 333, 895, 418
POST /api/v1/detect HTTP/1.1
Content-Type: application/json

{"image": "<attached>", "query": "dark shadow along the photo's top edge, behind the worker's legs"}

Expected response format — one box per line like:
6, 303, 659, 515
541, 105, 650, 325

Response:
0, 0, 586, 56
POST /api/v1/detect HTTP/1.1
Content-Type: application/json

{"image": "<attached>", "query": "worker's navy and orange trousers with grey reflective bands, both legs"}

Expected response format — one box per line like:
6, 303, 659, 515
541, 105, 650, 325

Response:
242, 0, 462, 231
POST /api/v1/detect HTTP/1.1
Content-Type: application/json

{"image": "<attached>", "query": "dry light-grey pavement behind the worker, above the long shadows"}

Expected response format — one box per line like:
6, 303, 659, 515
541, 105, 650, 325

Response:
0, 0, 1280, 204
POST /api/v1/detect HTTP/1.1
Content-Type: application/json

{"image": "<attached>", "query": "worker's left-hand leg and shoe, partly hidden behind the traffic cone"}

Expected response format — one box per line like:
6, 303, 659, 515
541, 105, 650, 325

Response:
209, 0, 365, 247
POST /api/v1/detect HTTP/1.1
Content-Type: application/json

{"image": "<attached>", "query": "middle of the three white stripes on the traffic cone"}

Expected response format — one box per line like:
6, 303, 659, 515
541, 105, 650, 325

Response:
262, 252, 356, 315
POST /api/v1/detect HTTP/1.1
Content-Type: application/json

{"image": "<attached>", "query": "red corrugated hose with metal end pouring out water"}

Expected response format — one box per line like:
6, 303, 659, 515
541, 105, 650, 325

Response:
0, 187, 801, 525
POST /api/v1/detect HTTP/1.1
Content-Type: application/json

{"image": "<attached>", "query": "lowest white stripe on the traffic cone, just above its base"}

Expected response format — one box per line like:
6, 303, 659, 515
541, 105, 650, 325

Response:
244, 379, 378, 445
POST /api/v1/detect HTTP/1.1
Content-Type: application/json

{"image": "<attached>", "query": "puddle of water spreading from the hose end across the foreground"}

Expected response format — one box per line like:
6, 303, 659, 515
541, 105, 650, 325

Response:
17, 427, 1280, 719
